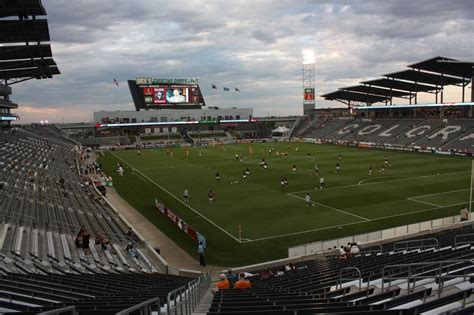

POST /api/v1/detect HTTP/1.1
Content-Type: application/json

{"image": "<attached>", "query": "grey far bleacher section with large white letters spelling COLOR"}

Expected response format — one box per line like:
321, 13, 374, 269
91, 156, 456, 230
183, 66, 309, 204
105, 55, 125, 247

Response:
299, 118, 474, 152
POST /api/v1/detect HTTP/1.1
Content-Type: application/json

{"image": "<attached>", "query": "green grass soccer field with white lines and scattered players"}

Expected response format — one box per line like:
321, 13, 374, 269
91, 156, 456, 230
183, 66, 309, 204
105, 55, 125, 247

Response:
99, 143, 471, 266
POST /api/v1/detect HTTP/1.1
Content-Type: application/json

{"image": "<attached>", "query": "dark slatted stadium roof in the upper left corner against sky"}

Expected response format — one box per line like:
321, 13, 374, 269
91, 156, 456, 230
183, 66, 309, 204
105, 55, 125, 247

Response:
0, 0, 60, 85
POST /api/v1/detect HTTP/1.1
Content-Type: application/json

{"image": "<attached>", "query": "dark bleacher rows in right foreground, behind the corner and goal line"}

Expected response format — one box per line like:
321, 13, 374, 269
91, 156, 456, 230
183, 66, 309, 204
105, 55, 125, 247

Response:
208, 225, 474, 315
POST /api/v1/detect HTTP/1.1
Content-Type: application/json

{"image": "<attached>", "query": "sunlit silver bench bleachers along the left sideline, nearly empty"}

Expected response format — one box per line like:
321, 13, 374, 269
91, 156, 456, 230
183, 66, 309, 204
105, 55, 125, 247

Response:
0, 127, 161, 273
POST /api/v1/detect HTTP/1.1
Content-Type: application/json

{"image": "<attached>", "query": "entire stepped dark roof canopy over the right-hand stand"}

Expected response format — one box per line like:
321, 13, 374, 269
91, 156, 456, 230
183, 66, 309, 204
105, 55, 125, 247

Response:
321, 57, 474, 105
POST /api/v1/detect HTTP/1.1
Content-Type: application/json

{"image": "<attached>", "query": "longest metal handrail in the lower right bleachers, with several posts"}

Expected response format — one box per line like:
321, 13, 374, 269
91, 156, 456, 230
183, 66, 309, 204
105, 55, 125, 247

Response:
382, 259, 474, 298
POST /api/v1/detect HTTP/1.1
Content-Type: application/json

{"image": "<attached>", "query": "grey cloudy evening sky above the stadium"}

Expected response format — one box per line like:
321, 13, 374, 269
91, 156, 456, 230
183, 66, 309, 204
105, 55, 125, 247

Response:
13, 0, 474, 122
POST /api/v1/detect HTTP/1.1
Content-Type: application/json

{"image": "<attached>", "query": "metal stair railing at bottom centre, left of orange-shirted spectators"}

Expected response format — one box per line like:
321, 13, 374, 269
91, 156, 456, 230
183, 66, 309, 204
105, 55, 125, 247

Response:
166, 273, 211, 315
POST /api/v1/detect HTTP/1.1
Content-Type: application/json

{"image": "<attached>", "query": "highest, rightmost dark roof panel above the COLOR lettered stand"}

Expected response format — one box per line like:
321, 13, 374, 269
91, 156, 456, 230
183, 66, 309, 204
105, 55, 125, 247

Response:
408, 57, 474, 78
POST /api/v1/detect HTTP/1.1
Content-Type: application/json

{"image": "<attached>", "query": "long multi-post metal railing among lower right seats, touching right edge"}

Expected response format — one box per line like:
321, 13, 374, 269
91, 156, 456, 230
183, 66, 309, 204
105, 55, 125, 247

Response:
382, 259, 474, 298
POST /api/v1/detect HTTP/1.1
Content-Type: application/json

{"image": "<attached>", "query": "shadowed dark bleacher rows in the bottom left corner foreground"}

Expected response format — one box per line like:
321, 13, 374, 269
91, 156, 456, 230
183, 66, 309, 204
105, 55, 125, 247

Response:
0, 274, 192, 315
